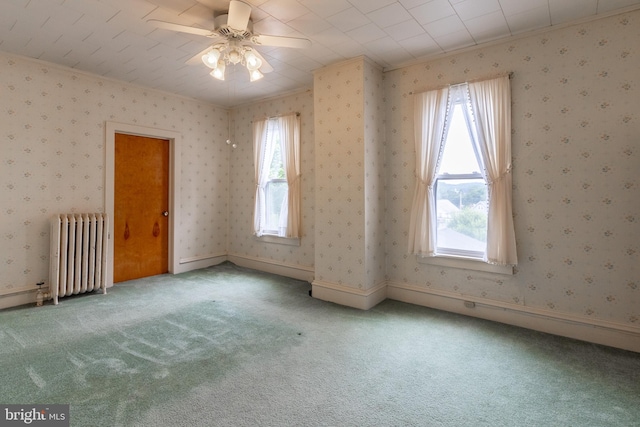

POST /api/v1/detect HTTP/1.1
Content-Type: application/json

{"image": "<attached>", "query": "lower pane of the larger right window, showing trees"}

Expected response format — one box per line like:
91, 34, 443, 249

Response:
436, 179, 488, 257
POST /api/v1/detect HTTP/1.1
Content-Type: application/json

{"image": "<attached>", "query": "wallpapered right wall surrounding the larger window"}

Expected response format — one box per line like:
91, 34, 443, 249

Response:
385, 12, 640, 326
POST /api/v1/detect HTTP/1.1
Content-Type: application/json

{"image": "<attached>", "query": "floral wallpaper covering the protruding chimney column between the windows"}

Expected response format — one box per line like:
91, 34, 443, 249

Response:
314, 58, 384, 290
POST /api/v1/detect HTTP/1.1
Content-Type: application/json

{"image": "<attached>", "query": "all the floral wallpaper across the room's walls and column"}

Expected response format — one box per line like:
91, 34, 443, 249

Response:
0, 6, 640, 336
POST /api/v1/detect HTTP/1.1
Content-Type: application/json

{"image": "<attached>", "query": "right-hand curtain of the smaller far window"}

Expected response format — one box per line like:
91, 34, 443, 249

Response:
278, 114, 301, 238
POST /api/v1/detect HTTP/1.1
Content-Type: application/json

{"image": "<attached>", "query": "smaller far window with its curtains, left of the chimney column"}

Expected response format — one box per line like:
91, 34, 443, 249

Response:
254, 114, 300, 238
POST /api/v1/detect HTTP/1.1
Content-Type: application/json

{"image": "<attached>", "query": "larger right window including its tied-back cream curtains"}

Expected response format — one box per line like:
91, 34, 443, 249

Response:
409, 76, 517, 266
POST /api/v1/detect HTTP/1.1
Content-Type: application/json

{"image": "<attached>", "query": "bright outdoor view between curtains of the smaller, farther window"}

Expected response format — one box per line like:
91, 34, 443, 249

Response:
264, 127, 289, 234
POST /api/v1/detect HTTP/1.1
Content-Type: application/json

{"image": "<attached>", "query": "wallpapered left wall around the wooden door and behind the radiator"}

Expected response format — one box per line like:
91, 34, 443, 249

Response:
0, 54, 229, 294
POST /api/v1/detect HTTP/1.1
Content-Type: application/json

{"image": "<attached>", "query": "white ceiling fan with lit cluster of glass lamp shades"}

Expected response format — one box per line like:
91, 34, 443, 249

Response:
147, 0, 311, 82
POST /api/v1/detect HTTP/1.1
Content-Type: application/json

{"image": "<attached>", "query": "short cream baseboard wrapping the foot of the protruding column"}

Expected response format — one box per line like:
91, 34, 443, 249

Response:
311, 280, 387, 310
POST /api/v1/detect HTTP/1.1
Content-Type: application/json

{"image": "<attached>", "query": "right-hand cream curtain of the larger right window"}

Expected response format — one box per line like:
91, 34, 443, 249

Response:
468, 76, 518, 265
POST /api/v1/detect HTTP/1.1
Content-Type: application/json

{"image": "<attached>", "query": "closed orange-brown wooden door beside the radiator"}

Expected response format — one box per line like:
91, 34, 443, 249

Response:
113, 133, 169, 283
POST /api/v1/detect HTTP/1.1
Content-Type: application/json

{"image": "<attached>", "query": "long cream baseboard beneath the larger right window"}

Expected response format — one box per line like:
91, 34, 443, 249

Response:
384, 283, 640, 352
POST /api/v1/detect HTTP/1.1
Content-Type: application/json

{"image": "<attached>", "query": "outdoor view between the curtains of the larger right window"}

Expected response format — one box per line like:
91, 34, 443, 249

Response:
435, 102, 488, 257
